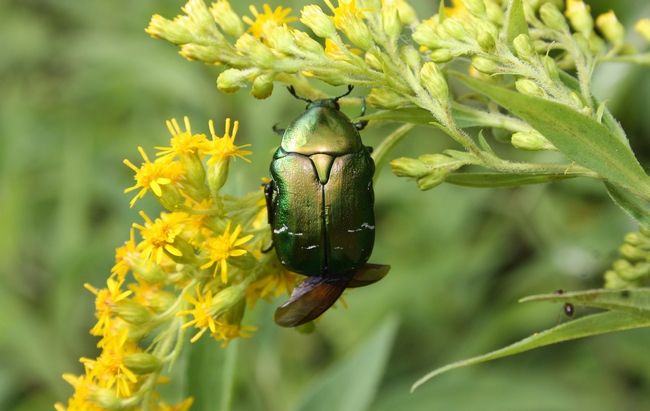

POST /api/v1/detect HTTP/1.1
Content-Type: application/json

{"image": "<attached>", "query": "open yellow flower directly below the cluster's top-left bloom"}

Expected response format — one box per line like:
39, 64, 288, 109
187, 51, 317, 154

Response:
133, 211, 188, 269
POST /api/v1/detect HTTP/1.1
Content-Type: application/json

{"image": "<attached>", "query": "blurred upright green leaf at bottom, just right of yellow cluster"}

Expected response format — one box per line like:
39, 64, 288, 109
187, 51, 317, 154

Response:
187, 337, 239, 411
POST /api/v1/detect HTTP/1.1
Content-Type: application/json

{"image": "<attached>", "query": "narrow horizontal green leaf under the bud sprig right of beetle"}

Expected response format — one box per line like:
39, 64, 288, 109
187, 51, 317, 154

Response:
445, 173, 576, 188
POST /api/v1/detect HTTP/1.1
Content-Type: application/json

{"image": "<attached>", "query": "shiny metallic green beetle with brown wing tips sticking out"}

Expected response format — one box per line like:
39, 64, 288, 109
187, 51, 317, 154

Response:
264, 86, 390, 327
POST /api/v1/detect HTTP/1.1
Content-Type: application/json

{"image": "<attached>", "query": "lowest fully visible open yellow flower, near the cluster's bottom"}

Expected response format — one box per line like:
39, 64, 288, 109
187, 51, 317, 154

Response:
80, 330, 138, 397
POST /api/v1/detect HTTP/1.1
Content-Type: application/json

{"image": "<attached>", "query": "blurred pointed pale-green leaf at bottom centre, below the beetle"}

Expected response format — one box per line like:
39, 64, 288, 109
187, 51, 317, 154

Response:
296, 317, 398, 411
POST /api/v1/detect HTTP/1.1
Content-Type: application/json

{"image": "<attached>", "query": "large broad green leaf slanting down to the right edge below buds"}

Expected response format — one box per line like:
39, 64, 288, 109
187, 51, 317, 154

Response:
452, 73, 650, 199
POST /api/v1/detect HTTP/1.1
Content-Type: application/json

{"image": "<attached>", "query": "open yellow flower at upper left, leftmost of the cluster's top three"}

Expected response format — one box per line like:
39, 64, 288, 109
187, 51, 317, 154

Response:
124, 147, 183, 207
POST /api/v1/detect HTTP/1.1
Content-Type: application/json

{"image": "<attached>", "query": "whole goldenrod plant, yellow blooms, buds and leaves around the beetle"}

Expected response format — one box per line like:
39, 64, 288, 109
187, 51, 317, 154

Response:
50, 0, 650, 411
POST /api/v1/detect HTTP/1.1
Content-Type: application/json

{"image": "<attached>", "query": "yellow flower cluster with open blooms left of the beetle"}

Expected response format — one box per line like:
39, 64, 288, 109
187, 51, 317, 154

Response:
56, 118, 297, 411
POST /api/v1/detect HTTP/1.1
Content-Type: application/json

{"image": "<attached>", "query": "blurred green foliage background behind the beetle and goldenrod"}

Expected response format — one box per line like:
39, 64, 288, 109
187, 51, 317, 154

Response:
0, 0, 650, 411
